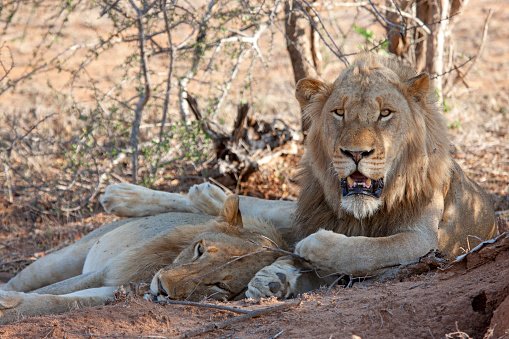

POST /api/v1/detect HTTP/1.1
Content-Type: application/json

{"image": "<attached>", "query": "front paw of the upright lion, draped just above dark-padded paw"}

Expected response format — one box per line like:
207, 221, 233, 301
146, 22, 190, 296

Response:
295, 230, 348, 271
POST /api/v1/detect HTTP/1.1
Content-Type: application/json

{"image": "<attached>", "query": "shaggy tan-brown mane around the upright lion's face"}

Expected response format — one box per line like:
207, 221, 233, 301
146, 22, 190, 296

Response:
295, 55, 453, 241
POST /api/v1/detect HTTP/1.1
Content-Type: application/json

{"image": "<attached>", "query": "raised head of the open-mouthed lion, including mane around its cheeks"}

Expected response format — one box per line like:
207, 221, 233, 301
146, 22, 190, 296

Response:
296, 55, 451, 219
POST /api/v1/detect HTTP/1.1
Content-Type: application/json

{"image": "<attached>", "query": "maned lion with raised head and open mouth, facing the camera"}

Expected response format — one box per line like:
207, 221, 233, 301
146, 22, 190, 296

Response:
102, 55, 496, 298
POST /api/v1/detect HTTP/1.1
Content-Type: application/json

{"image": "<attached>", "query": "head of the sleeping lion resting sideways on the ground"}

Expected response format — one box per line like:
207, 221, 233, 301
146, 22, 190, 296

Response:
150, 197, 280, 301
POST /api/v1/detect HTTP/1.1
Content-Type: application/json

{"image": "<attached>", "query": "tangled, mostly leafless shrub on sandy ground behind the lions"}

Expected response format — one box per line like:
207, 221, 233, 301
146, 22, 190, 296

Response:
0, 0, 484, 226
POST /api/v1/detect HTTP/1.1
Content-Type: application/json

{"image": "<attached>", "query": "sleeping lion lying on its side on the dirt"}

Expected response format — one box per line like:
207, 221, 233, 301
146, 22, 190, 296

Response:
0, 197, 285, 323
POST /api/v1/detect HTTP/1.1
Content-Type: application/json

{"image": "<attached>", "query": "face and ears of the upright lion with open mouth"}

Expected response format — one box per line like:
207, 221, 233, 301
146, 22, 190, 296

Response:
296, 56, 440, 219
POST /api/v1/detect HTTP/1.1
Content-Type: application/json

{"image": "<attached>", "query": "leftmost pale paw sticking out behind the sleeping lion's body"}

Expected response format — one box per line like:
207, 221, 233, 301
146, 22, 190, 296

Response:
99, 183, 152, 217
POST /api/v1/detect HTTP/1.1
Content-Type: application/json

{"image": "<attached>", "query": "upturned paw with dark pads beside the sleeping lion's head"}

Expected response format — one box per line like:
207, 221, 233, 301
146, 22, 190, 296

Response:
246, 259, 301, 300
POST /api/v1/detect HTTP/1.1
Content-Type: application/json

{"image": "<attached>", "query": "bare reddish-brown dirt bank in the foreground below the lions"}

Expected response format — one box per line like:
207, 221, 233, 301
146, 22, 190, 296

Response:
0, 233, 509, 338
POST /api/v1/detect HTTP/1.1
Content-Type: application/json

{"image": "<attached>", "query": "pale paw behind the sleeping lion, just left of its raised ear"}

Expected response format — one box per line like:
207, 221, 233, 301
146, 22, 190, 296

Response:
187, 183, 228, 215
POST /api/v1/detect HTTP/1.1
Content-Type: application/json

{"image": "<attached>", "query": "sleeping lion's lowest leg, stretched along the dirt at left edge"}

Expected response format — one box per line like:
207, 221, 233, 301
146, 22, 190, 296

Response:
0, 286, 118, 324
